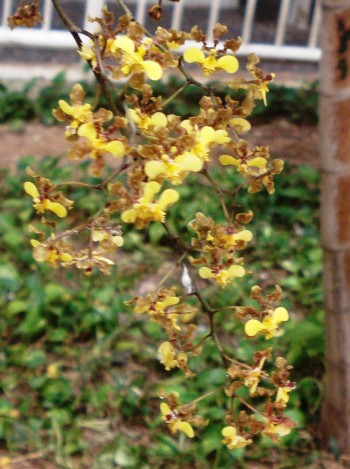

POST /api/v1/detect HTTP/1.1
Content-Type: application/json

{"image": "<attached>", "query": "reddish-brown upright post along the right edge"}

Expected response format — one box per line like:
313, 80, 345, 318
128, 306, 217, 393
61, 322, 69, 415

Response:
320, 0, 350, 454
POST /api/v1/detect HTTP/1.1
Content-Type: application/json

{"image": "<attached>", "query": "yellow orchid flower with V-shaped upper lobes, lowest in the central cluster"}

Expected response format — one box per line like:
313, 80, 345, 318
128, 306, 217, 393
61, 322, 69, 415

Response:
121, 181, 179, 228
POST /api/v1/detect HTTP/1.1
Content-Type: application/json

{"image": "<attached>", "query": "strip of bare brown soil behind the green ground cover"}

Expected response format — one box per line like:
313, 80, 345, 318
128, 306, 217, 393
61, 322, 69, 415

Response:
0, 118, 319, 169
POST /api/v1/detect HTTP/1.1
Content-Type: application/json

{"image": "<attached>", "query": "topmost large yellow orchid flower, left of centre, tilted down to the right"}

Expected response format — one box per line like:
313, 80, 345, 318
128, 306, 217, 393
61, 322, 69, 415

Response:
110, 36, 163, 81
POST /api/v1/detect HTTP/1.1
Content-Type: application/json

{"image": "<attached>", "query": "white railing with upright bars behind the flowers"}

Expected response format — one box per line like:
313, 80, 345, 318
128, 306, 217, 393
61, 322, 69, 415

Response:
0, 0, 321, 62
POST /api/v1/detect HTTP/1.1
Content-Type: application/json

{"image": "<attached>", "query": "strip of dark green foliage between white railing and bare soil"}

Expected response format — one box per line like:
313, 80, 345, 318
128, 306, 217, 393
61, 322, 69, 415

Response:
0, 72, 318, 125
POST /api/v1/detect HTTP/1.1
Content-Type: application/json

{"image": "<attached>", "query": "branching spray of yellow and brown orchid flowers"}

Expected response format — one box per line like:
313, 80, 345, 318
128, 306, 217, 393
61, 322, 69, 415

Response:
15, 0, 295, 449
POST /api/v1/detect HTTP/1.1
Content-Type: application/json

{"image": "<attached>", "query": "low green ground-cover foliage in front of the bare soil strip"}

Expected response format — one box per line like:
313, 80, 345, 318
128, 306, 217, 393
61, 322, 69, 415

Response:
0, 155, 324, 469
